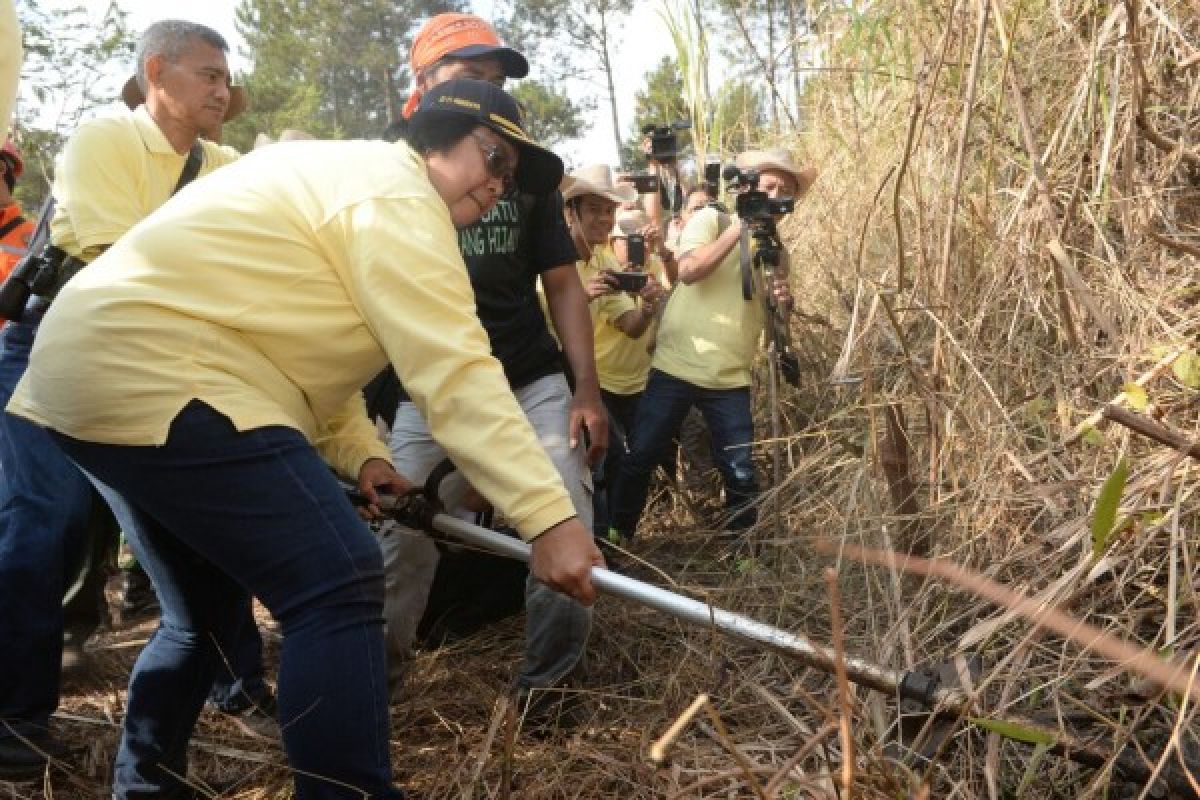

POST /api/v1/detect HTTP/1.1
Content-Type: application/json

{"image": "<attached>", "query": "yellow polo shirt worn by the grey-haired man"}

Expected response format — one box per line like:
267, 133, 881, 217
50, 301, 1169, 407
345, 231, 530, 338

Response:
50, 106, 240, 261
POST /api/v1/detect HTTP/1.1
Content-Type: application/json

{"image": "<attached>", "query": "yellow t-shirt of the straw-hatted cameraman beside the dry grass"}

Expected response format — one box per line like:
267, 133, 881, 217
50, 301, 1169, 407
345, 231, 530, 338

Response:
652, 209, 763, 389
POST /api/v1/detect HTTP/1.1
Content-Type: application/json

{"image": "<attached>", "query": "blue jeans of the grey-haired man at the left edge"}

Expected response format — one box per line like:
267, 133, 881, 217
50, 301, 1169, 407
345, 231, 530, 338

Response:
0, 315, 94, 736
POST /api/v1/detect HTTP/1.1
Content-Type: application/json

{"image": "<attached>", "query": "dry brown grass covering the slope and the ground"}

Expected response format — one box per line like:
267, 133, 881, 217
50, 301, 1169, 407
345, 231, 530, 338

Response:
14, 0, 1200, 800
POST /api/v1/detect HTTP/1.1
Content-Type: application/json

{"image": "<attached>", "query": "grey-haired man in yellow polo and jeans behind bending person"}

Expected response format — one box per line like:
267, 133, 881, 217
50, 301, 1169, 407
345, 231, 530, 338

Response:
0, 20, 248, 780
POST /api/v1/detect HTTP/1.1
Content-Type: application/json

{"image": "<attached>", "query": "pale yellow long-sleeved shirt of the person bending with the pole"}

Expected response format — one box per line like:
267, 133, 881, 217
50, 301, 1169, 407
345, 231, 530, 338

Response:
8, 142, 575, 539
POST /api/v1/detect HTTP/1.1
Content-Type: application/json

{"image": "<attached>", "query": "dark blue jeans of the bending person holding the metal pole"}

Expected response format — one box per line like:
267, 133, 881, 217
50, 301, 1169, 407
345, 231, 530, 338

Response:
55, 401, 403, 800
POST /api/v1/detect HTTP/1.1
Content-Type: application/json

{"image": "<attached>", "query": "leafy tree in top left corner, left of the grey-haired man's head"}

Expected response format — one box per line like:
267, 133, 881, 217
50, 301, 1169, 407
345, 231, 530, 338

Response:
14, 0, 137, 210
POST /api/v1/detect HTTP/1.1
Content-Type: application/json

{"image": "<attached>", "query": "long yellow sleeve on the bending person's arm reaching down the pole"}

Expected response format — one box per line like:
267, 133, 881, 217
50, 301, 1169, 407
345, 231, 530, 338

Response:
338, 197, 575, 540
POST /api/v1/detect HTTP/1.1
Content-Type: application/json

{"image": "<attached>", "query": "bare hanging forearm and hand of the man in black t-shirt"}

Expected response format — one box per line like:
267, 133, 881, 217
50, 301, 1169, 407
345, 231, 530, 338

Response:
541, 264, 608, 464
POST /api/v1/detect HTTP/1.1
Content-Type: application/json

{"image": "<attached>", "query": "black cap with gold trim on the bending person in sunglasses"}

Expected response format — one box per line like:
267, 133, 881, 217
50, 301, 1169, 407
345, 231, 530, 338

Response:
409, 79, 563, 194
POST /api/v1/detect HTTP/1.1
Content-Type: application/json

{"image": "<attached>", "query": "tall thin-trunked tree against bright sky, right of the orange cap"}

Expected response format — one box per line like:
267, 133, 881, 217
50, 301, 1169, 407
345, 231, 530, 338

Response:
502, 0, 634, 163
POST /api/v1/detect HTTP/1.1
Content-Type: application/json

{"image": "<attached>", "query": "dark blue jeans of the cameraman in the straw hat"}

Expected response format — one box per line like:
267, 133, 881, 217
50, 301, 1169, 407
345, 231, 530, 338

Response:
608, 369, 758, 537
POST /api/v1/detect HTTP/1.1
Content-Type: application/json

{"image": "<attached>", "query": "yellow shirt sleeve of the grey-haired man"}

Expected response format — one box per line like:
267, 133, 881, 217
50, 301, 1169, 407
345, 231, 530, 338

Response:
54, 121, 145, 260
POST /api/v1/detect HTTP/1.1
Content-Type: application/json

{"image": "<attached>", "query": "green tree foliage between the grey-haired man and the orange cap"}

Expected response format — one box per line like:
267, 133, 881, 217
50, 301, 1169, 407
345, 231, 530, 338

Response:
226, 0, 466, 148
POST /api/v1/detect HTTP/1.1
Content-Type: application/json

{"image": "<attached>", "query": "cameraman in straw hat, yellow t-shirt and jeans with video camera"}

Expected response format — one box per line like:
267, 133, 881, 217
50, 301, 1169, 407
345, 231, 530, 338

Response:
610, 151, 816, 540
